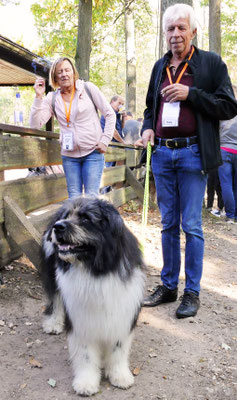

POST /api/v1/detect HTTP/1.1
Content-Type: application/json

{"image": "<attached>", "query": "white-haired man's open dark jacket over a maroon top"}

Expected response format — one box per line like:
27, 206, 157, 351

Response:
142, 47, 237, 173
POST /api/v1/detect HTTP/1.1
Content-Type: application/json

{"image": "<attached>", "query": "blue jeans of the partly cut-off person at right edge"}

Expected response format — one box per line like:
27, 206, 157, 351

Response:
218, 149, 237, 219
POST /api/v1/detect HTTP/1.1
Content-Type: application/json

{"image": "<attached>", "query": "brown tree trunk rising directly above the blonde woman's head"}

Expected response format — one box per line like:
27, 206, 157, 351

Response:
75, 0, 92, 81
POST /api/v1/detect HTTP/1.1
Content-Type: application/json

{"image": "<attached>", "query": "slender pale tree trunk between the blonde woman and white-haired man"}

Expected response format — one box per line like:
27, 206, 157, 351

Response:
124, 0, 136, 117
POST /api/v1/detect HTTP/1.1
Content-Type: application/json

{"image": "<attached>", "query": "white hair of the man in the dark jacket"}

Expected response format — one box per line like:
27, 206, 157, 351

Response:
163, 3, 197, 32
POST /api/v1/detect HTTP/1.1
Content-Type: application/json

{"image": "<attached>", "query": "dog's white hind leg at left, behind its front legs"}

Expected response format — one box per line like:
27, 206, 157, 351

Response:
43, 293, 65, 335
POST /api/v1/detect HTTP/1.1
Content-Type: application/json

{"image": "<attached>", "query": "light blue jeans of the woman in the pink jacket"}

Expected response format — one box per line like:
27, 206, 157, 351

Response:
62, 150, 104, 198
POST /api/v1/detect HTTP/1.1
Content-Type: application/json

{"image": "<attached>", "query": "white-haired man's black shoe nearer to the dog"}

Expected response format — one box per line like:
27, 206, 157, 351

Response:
143, 285, 178, 307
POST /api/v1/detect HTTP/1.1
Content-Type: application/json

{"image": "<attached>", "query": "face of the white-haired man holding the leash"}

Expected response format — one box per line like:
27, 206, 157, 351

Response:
165, 18, 196, 57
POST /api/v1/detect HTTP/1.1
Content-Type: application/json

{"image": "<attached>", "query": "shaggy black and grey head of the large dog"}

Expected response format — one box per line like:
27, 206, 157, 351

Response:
44, 197, 143, 275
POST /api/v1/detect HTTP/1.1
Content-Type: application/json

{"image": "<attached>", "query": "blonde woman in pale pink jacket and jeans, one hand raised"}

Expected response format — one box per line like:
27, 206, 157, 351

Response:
30, 57, 116, 198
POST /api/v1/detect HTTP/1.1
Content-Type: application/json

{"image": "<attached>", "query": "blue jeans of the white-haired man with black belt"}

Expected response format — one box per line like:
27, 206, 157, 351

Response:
152, 144, 207, 294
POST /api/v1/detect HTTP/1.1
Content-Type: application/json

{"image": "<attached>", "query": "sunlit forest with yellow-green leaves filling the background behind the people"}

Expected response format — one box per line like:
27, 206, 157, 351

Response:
0, 0, 237, 126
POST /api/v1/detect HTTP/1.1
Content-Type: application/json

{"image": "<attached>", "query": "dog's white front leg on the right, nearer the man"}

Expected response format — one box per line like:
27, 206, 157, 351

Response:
105, 334, 134, 389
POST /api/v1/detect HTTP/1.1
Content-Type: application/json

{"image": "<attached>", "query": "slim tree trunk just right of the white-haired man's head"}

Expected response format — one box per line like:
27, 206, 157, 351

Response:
209, 0, 221, 55
